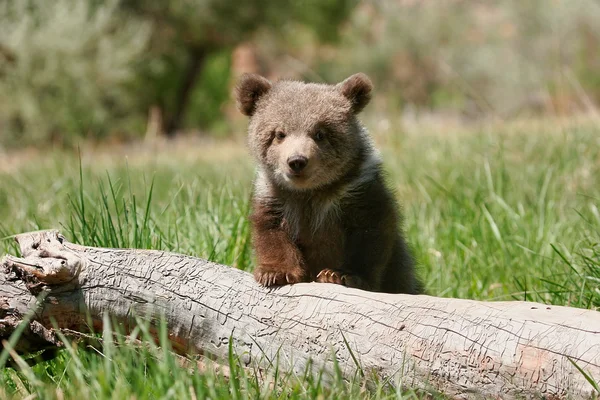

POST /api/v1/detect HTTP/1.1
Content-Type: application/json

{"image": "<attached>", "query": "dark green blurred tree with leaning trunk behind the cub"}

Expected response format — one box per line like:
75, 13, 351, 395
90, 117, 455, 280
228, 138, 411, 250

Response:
122, 0, 358, 136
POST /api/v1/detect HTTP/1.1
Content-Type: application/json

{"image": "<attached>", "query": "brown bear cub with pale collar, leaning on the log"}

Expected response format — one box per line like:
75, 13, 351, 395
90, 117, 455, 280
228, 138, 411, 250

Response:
236, 73, 421, 293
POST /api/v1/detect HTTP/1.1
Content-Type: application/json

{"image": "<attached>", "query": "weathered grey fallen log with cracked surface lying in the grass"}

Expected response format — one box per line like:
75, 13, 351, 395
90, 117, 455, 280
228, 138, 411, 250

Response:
0, 231, 600, 398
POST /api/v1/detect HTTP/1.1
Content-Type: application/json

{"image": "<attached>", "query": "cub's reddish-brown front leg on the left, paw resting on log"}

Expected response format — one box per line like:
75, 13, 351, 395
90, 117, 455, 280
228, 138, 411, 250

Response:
250, 204, 308, 286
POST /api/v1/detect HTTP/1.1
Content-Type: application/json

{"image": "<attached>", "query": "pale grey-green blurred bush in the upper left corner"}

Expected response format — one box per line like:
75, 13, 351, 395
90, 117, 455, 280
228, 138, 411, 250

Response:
0, 0, 150, 144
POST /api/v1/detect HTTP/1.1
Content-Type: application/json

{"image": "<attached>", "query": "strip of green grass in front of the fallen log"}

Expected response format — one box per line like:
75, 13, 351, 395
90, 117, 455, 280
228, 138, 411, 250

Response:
0, 318, 416, 399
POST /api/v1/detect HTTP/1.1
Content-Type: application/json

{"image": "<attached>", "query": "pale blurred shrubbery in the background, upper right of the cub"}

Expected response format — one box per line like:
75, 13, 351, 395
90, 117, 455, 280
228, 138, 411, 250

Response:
318, 0, 600, 118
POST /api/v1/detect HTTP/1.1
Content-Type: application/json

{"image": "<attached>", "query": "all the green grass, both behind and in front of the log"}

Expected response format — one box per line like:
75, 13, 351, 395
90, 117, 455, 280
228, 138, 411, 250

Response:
0, 122, 600, 399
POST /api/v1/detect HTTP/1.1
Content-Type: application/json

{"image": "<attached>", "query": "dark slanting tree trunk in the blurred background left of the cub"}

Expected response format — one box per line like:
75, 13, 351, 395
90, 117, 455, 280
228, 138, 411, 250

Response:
165, 47, 207, 137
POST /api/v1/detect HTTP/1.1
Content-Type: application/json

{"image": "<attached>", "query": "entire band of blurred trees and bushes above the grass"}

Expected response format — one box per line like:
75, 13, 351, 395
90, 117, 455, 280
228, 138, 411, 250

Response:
0, 0, 600, 145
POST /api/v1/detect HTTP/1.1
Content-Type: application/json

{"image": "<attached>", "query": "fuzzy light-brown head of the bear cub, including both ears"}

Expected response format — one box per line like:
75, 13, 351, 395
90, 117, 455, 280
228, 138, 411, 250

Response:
236, 74, 372, 190
